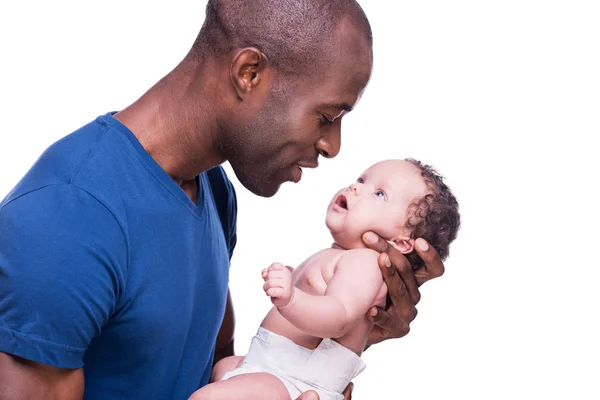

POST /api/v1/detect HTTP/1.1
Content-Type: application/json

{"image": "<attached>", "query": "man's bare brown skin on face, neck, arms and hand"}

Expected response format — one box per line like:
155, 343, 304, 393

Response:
0, 15, 443, 400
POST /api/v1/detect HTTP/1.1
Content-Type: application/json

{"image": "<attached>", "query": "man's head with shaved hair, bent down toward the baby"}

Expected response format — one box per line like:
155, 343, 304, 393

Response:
187, 0, 372, 196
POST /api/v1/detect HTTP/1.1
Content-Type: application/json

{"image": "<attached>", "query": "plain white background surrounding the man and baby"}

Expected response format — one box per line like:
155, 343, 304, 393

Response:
0, 0, 600, 400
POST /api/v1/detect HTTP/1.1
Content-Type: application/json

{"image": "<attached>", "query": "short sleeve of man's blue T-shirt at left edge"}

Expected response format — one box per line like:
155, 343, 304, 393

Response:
0, 185, 127, 368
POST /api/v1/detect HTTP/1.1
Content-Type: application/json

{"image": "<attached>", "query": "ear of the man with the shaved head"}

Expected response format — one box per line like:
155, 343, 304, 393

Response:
229, 47, 268, 101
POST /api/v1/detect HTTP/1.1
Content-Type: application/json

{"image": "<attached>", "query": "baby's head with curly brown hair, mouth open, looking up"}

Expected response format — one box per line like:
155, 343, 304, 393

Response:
326, 159, 460, 268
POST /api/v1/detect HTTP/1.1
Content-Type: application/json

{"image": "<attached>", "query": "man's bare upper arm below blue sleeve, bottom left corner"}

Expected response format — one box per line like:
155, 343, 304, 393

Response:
0, 352, 84, 400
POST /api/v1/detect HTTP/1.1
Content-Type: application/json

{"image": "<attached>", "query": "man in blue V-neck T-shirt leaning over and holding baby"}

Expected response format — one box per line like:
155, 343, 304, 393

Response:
0, 0, 443, 400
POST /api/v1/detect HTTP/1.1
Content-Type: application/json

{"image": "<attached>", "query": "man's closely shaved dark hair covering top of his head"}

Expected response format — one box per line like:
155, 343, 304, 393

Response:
193, 0, 372, 75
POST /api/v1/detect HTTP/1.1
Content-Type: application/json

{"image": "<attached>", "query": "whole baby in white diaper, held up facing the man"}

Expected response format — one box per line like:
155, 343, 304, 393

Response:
191, 159, 460, 400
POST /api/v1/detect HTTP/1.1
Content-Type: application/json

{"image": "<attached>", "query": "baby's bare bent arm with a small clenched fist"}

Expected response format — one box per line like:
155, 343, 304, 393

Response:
263, 249, 383, 338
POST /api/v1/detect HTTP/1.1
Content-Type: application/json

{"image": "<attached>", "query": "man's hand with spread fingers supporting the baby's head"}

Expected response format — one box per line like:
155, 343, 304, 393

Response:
363, 232, 444, 345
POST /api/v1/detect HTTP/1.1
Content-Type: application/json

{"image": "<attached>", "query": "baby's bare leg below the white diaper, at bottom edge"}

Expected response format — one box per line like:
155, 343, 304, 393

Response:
189, 372, 295, 400
